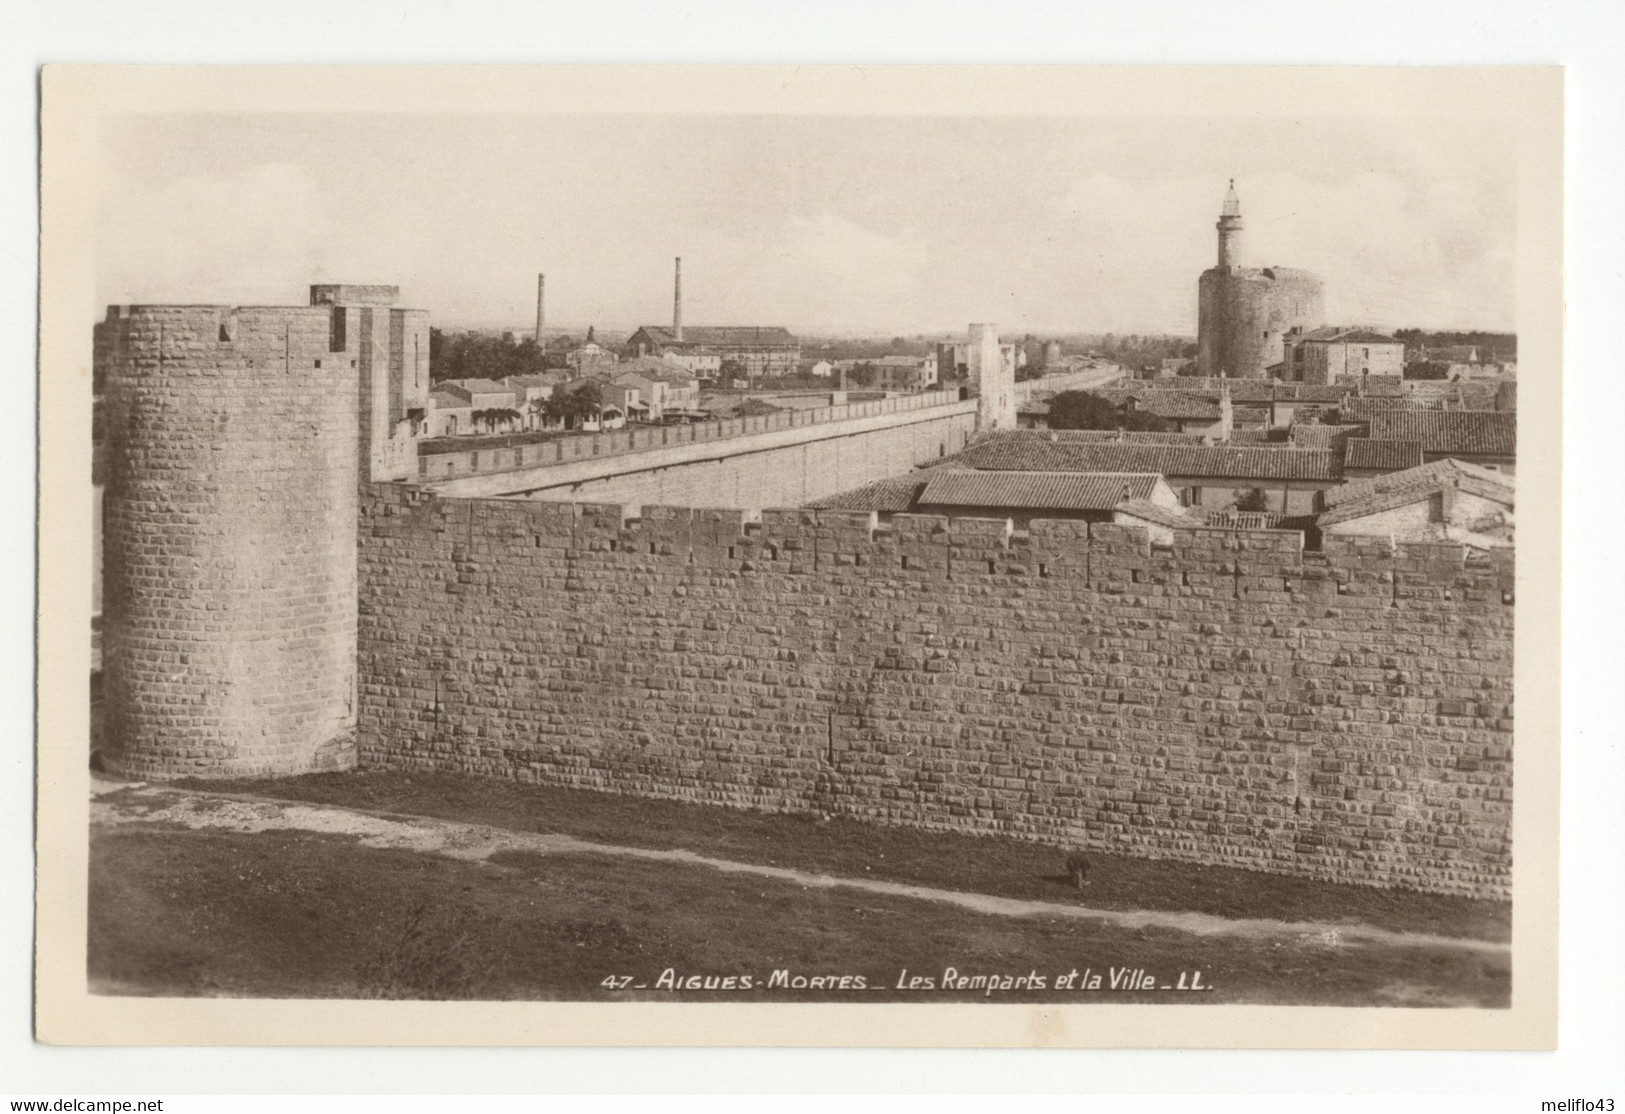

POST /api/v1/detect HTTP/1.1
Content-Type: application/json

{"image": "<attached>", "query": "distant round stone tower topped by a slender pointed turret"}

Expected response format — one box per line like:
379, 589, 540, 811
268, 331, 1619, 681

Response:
1196, 180, 1326, 378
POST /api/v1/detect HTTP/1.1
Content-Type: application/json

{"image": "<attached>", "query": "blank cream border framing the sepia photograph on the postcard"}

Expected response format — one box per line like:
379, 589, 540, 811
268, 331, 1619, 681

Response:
37, 67, 1563, 1047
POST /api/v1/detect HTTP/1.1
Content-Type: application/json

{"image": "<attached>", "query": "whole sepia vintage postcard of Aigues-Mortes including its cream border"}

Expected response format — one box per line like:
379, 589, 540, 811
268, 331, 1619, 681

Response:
37, 67, 1563, 1047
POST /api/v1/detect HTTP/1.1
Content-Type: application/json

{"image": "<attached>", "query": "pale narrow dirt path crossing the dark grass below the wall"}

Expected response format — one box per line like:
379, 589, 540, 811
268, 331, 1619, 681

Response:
91, 781, 1510, 956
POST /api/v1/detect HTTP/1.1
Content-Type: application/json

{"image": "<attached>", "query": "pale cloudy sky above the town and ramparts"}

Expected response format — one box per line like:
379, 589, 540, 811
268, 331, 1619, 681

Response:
98, 114, 1516, 335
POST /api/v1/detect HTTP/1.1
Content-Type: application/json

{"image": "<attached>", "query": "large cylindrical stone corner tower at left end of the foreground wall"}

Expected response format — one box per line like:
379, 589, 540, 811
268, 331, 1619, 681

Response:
96, 305, 359, 778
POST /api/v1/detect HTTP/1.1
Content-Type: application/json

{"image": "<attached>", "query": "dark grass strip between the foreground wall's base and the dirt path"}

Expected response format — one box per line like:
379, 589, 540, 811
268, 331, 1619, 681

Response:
182, 773, 1511, 942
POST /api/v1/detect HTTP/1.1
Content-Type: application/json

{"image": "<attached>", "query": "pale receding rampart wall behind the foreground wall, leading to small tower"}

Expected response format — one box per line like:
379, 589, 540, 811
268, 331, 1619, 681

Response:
426, 396, 977, 508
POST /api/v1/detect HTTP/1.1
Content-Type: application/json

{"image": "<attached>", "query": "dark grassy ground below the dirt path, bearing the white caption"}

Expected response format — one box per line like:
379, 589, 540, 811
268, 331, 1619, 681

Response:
89, 823, 1508, 1005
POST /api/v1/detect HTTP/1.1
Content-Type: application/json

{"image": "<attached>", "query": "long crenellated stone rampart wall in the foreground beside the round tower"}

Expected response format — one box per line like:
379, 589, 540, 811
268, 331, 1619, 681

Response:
359, 486, 1513, 898
